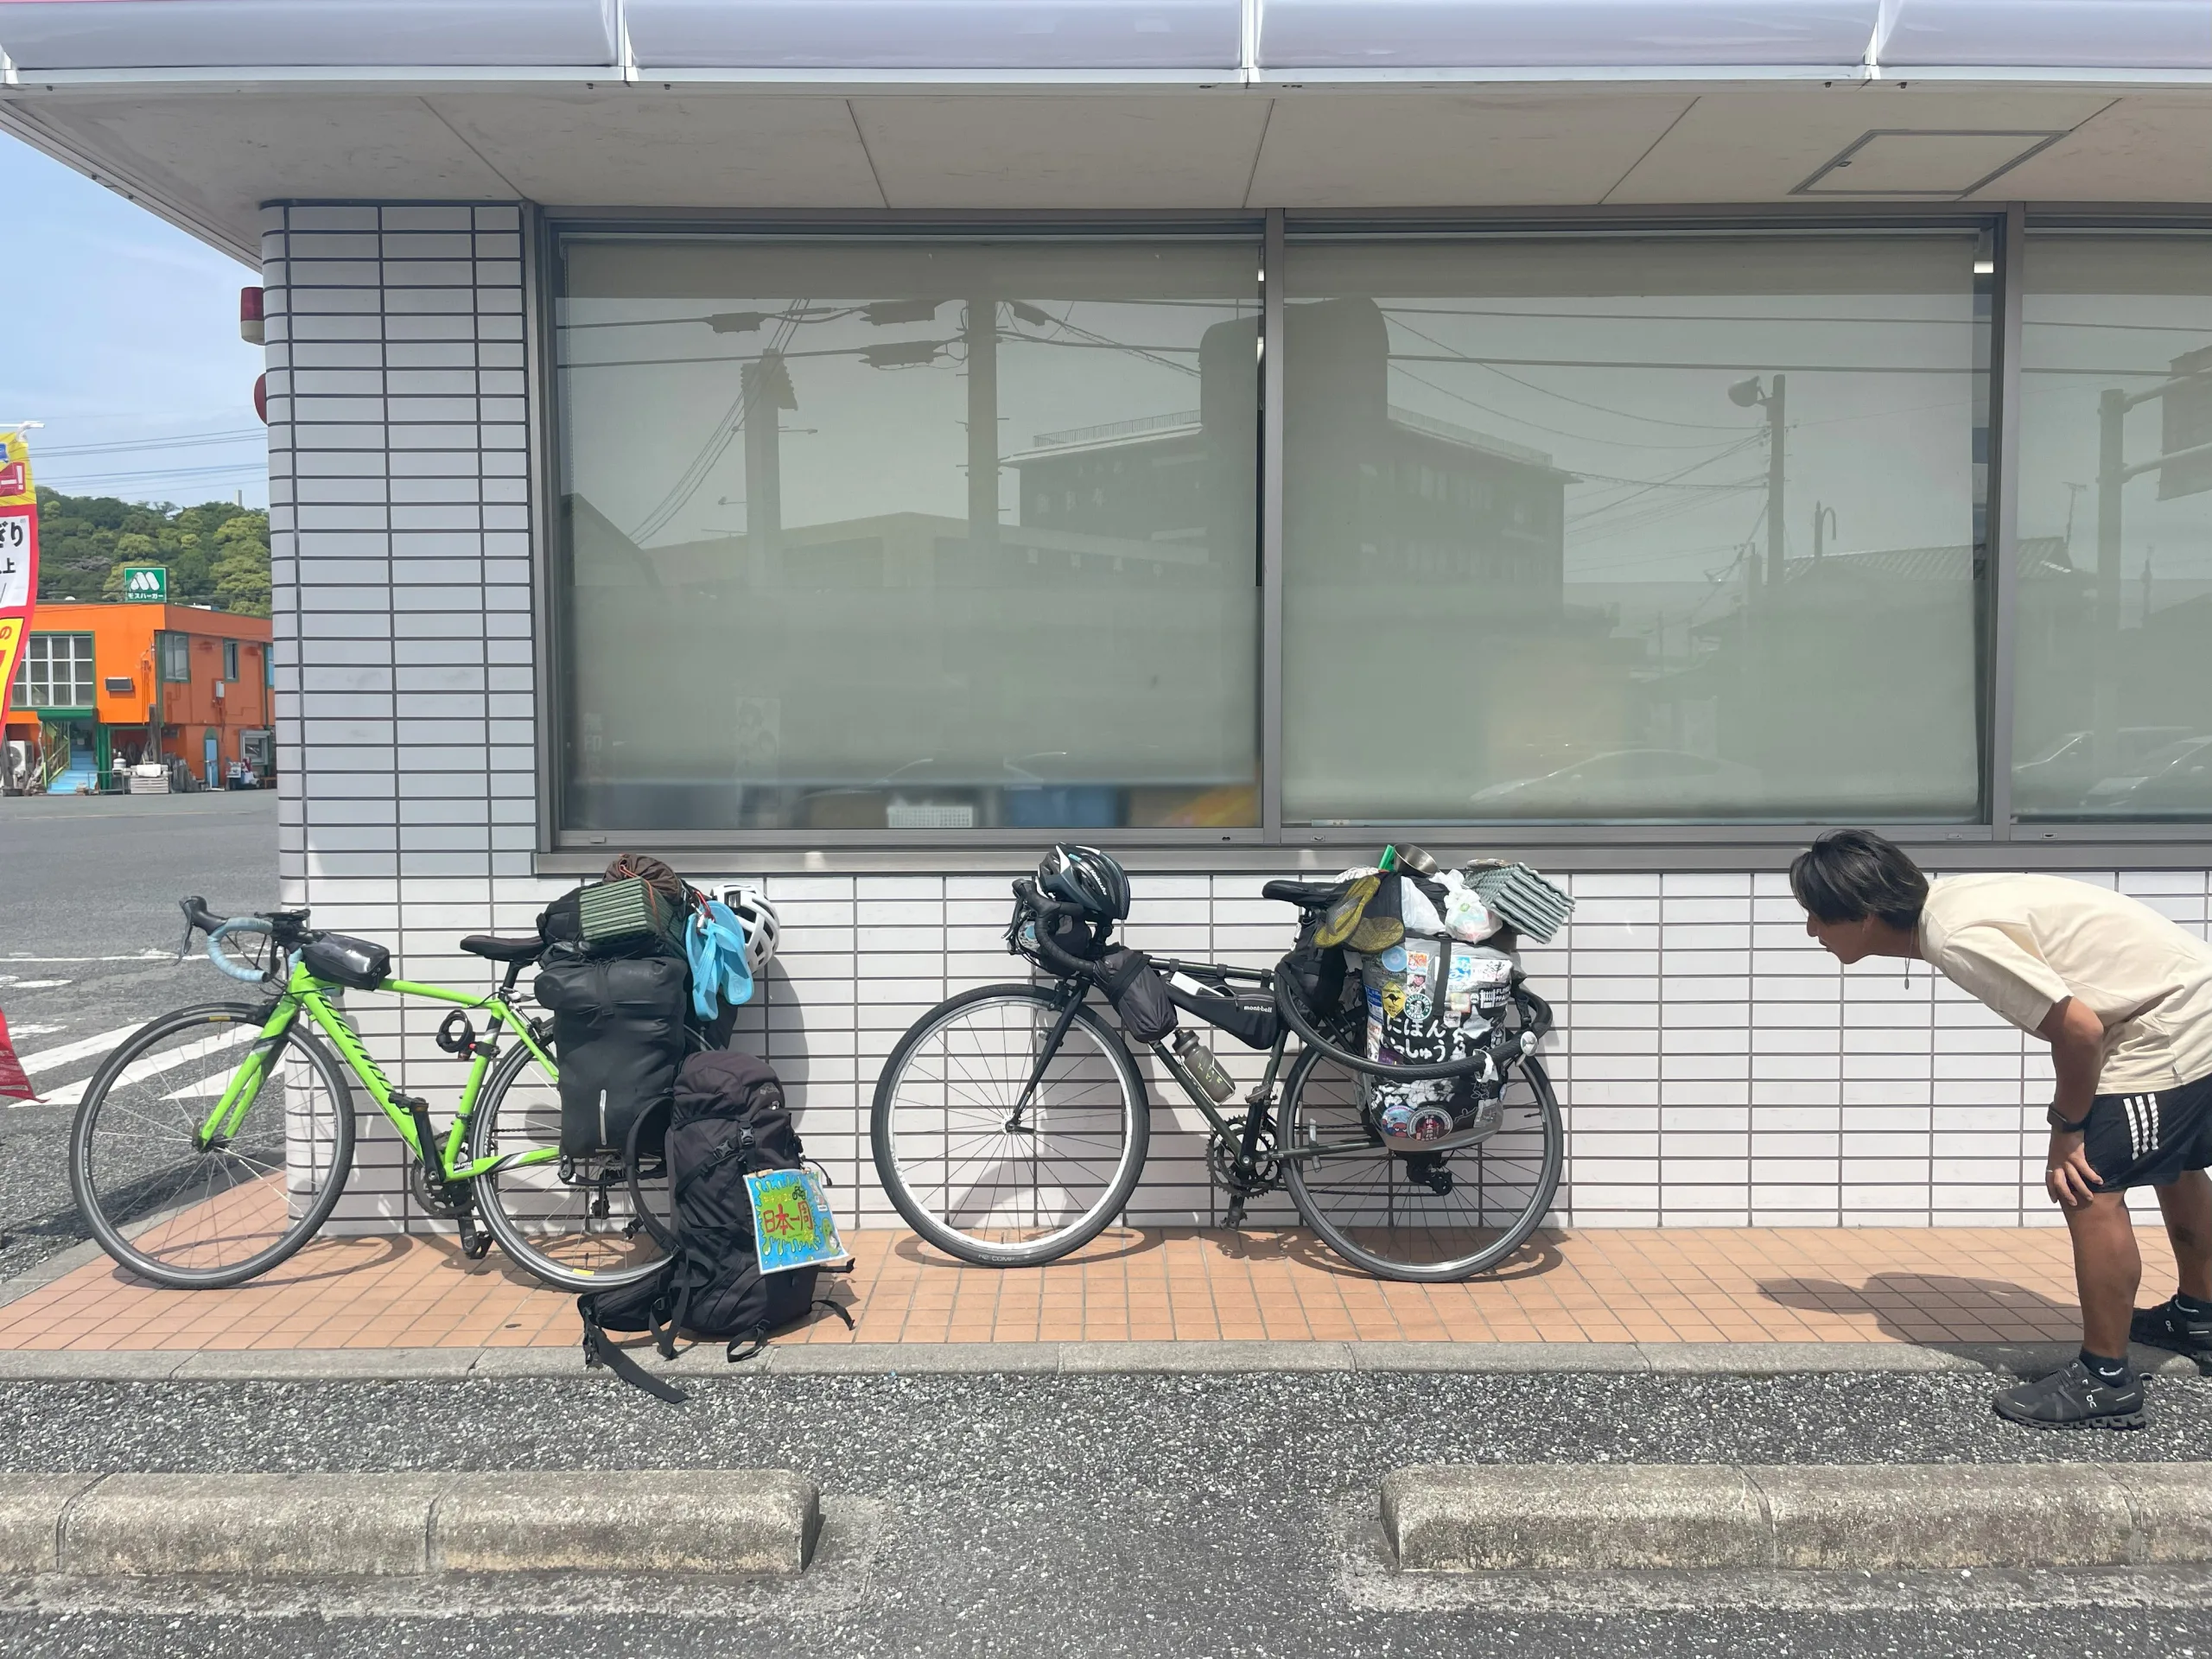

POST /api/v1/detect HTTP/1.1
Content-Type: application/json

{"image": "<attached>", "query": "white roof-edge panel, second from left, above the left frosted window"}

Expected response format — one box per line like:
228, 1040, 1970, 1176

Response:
628, 0, 1241, 71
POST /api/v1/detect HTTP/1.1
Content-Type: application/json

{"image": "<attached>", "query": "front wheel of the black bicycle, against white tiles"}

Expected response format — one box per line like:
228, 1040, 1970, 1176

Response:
869, 984, 1153, 1268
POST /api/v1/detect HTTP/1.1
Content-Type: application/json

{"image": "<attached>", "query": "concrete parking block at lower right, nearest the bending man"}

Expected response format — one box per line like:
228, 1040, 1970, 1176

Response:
1382, 1465, 2212, 1573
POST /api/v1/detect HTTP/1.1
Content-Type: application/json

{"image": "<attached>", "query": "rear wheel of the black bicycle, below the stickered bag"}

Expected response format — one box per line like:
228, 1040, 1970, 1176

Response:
1283, 1048, 1566, 1283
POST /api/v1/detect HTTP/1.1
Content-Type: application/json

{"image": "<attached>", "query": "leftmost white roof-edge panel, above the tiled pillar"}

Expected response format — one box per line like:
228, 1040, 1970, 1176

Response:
0, 0, 620, 71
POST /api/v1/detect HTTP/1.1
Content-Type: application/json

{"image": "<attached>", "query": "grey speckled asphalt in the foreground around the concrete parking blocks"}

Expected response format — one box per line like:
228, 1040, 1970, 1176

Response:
0, 1374, 2212, 1659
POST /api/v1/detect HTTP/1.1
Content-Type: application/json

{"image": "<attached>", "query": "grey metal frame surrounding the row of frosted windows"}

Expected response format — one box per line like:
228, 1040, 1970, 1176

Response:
524, 201, 2212, 874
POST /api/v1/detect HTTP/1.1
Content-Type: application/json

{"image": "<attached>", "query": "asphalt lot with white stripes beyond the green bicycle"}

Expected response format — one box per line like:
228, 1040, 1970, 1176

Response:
0, 790, 276, 1279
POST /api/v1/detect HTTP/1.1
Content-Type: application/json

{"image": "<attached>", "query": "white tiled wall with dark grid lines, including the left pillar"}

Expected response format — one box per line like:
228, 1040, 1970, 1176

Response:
264, 206, 2208, 1230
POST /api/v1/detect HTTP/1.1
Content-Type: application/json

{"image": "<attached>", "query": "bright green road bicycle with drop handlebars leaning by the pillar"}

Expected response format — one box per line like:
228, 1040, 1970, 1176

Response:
68, 898, 668, 1289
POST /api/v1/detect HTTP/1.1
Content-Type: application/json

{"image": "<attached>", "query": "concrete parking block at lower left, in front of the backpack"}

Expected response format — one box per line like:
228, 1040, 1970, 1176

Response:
0, 1469, 821, 1577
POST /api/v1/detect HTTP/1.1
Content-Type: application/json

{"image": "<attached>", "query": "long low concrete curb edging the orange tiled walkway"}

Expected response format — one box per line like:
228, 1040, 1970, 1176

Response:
0, 1340, 2201, 1382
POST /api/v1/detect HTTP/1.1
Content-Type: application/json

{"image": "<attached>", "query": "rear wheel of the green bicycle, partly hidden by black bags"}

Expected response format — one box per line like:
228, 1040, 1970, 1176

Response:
467, 1042, 671, 1292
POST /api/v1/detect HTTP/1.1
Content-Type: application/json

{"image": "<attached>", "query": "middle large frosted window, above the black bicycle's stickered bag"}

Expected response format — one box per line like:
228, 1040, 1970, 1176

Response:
1283, 232, 1991, 825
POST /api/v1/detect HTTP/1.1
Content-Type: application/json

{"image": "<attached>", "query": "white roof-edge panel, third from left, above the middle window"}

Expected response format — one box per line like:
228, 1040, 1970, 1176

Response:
1259, 0, 1876, 68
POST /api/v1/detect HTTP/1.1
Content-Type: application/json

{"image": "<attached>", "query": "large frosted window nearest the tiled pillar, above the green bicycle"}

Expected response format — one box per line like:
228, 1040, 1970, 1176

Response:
556, 237, 1259, 832
